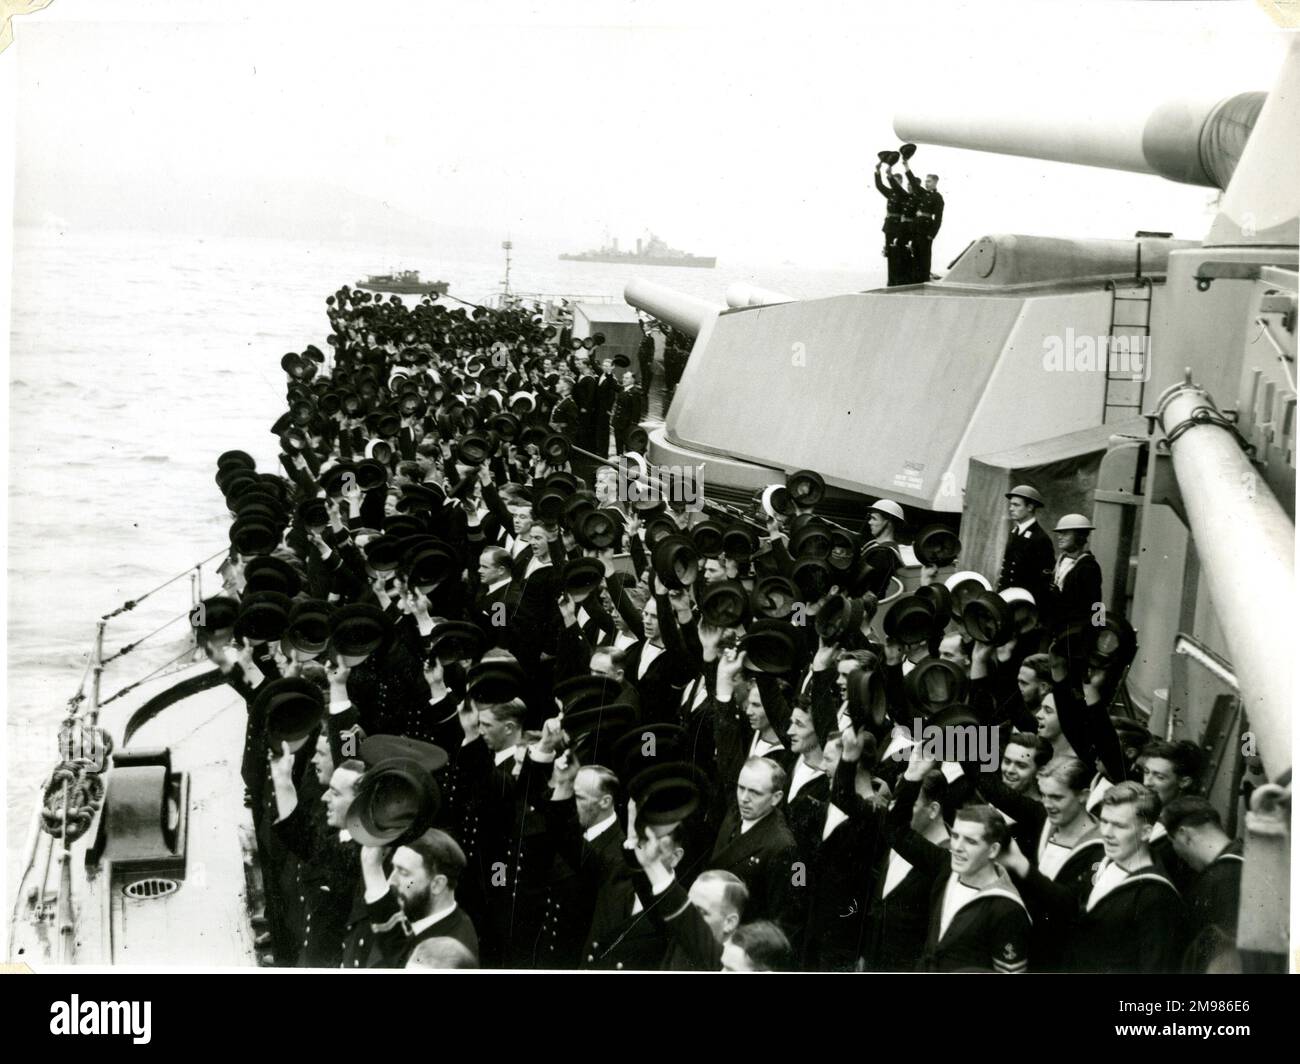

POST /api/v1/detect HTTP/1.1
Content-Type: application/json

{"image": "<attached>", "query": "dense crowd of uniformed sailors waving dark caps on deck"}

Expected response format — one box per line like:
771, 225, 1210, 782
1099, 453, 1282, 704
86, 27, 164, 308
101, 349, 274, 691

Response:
195, 287, 1242, 973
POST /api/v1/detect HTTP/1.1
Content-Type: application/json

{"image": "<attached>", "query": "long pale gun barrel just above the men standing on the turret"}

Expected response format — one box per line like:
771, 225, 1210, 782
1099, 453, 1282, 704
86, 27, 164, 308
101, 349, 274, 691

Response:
894, 92, 1268, 189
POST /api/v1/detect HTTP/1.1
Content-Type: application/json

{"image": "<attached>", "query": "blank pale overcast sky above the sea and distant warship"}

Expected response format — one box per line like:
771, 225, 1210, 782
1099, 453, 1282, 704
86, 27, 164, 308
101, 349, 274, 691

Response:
0, 0, 1282, 265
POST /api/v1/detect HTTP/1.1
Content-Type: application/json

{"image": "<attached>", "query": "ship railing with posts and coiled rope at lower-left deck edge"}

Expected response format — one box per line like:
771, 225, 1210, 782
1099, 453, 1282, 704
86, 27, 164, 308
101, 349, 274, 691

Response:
7, 548, 229, 964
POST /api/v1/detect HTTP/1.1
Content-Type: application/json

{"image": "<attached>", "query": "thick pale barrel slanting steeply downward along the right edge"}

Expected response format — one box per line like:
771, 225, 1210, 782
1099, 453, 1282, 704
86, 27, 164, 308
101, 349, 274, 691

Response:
1156, 380, 1295, 779
